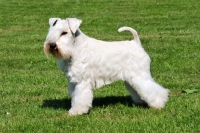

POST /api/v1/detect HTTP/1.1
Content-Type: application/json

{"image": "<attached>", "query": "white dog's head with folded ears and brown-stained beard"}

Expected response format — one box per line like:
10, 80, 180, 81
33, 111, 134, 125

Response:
44, 18, 82, 59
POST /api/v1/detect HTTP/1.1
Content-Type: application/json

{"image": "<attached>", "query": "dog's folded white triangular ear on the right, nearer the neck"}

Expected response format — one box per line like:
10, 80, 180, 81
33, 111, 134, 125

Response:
67, 18, 82, 33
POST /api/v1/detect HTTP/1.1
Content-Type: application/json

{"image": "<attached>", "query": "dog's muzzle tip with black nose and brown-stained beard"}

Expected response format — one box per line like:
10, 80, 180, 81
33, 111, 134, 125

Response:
44, 43, 62, 59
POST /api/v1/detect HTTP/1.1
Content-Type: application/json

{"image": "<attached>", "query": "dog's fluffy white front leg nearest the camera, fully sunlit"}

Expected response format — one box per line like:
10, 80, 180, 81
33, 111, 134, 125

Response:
69, 81, 93, 115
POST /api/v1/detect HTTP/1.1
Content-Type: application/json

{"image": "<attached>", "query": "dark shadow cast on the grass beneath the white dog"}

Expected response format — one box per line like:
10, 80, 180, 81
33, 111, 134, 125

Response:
42, 96, 148, 110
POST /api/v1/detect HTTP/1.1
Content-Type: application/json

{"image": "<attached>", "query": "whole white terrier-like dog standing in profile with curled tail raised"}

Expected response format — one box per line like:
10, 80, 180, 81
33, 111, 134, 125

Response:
44, 18, 169, 115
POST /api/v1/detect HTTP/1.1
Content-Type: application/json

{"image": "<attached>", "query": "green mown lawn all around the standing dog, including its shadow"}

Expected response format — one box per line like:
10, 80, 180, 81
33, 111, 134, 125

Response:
0, 0, 200, 133
